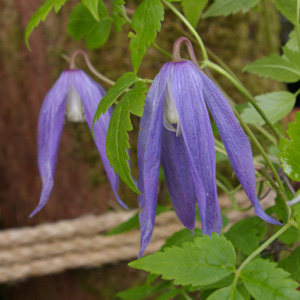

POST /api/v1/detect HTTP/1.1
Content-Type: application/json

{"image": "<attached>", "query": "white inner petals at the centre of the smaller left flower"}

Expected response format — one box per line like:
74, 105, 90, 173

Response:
66, 84, 85, 122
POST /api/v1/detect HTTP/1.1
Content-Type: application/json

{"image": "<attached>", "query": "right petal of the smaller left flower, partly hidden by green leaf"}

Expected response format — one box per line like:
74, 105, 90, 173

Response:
69, 70, 127, 209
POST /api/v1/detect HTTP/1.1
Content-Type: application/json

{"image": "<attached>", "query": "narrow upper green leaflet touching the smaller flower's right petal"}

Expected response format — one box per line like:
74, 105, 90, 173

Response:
92, 72, 138, 128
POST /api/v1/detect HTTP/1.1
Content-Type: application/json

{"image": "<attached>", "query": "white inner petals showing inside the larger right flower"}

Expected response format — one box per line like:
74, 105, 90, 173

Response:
164, 75, 182, 136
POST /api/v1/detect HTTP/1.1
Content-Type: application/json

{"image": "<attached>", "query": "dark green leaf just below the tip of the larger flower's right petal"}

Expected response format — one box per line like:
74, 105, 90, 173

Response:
225, 217, 267, 255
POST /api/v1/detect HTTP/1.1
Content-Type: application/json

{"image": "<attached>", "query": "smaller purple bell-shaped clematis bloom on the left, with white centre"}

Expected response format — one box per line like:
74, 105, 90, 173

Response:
30, 70, 127, 217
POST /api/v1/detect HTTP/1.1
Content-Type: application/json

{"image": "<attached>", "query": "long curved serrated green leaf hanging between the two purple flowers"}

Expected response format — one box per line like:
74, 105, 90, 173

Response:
106, 81, 148, 194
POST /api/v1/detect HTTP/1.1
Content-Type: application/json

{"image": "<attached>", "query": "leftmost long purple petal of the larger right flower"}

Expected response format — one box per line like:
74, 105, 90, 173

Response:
138, 64, 171, 257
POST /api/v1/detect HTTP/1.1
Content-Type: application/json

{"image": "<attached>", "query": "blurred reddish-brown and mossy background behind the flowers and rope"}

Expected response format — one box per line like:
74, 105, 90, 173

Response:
0, 0, 290, 300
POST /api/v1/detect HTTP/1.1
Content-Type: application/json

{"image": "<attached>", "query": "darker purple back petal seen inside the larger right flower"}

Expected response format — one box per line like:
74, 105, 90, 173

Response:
161, 128, 196, 231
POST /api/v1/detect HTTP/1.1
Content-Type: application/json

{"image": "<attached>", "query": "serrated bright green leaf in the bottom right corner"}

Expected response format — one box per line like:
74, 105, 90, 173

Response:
240, 259, 300, 300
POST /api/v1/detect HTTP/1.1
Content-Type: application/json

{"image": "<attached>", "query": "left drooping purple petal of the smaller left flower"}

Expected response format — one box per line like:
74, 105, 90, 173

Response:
30, 72, 71, 217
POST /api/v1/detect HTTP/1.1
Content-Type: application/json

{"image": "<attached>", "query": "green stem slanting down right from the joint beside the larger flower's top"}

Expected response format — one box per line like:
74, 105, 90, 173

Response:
204, 61, 280, 140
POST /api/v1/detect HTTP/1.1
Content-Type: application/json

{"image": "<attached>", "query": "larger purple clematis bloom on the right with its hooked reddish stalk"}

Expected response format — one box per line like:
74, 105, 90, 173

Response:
138, 38, 280, 256
